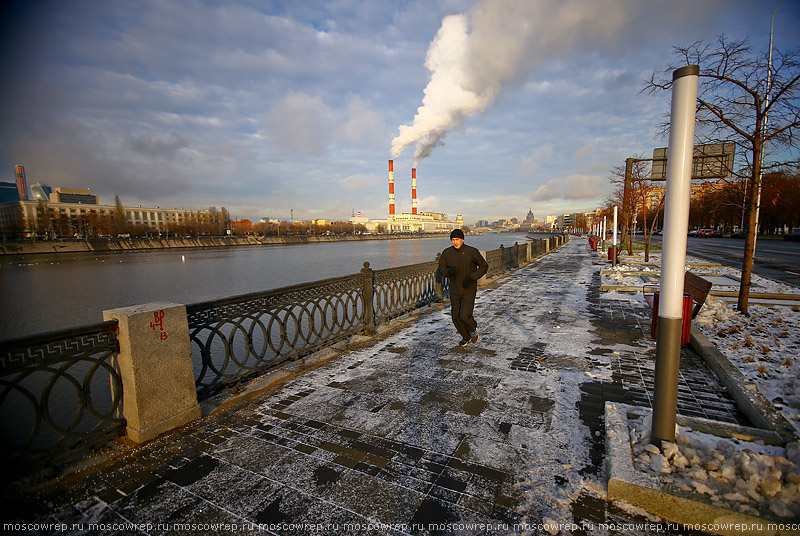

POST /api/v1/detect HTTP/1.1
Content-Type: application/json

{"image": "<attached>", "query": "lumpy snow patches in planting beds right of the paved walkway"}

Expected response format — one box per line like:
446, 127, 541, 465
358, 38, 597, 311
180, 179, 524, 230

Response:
608, 251, 800, 519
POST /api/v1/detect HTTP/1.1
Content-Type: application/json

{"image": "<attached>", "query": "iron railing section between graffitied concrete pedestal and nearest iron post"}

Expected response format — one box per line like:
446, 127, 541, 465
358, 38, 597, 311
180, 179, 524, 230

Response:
186, 274, 364, 400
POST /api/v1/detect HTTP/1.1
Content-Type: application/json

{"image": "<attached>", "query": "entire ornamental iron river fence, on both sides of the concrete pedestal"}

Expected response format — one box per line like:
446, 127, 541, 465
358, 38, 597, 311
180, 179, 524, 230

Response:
0, 236, 567, 477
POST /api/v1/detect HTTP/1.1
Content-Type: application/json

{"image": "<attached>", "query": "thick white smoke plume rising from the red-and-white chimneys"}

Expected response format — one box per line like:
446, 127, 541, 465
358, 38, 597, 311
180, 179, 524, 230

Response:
392, 0, 638, 165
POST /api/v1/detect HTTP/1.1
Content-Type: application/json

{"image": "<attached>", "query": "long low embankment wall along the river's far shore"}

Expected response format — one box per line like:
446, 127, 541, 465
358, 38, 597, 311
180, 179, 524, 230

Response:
0, 233, 456, 255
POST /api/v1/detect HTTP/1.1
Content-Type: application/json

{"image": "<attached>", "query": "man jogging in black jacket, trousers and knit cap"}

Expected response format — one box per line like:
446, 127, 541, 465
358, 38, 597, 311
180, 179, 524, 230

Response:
439, 229, 489, 346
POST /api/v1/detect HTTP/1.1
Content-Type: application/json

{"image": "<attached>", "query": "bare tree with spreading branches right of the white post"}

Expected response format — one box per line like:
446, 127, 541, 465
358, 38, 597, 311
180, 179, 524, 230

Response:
644, 35, 800, 314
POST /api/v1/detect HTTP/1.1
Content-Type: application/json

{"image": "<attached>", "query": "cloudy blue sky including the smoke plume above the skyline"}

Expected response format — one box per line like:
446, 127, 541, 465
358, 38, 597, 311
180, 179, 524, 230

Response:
0, 0, 800, 224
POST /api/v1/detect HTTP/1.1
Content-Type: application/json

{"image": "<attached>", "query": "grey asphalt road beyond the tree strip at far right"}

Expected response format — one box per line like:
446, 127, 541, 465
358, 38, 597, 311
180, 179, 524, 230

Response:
637, 236, 800, 287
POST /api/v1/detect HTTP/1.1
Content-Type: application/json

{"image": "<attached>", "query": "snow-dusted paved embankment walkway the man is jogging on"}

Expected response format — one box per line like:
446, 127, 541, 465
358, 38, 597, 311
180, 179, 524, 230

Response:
4, 240, 748, 535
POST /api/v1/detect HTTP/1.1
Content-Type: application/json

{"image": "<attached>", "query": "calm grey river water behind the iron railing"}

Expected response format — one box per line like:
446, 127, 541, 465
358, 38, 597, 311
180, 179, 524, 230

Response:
0, 233, 527, 340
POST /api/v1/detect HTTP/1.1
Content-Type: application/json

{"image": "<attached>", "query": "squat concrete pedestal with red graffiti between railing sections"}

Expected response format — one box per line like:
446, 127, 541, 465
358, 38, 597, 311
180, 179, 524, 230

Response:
103, 303, 202, 443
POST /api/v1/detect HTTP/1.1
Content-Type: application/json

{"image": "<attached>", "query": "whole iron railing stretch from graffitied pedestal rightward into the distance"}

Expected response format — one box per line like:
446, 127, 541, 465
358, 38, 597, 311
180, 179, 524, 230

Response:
186, 238, 559, 400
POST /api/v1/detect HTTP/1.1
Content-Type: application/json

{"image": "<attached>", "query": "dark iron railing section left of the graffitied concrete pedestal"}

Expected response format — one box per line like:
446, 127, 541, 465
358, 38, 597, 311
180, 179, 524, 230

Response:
0, 321, 125, 476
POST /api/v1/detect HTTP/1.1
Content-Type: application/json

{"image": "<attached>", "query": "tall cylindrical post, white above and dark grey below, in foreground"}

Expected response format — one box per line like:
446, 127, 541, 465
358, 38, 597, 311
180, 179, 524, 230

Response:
650, 65, 700, 446
